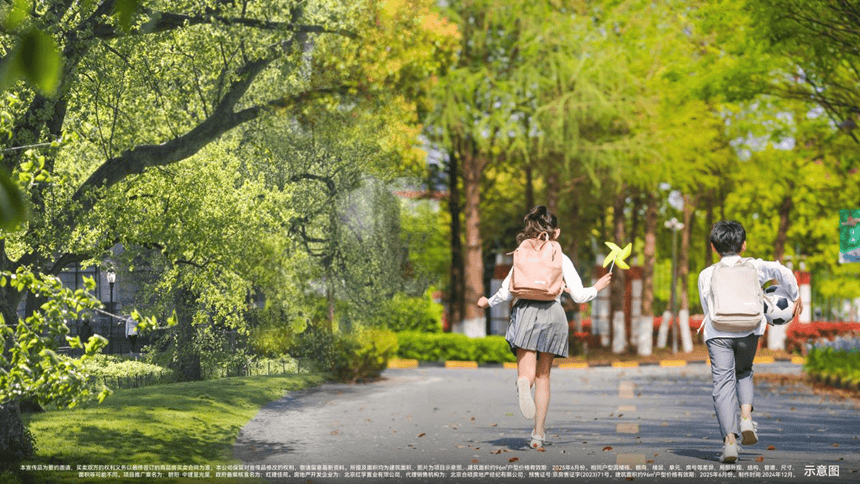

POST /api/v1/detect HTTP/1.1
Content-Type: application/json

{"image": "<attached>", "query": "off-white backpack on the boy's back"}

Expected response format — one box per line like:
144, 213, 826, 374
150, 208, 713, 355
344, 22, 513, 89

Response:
699, 258, 764, 333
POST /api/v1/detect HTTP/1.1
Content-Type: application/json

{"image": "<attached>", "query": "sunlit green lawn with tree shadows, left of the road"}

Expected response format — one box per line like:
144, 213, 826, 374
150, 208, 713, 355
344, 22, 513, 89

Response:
11, 374, 326, 484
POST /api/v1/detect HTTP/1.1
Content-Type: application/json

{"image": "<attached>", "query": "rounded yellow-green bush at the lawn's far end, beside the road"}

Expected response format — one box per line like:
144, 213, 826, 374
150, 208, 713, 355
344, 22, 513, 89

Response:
331, 328, 397, 383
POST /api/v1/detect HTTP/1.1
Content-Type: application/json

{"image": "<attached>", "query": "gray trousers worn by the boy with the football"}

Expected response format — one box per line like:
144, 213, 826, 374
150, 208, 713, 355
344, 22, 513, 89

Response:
707, 334, 759, 440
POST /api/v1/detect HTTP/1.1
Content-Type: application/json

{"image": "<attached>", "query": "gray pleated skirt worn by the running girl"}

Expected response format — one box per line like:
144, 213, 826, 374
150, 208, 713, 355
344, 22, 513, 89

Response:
505, 299, 568, 358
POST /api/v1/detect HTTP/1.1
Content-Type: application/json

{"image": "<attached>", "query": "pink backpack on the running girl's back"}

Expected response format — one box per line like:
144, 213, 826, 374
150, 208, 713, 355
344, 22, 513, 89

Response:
509, 232, 564, 301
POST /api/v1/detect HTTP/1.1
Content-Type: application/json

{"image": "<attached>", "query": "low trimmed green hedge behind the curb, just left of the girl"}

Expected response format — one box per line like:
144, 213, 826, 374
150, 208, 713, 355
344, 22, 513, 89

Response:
397, 331, 516, 363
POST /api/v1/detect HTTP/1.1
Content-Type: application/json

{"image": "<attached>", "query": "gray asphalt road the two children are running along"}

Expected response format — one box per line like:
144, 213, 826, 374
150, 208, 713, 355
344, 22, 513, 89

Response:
234, 362, 860, 484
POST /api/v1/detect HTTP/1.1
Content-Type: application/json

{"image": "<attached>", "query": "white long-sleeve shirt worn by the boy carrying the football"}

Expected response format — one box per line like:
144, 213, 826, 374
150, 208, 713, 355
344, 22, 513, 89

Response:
699, 255, 800, 341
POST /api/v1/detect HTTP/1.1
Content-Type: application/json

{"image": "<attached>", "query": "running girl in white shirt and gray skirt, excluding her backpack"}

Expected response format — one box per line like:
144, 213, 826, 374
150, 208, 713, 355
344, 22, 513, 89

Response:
478, 205, 612, 449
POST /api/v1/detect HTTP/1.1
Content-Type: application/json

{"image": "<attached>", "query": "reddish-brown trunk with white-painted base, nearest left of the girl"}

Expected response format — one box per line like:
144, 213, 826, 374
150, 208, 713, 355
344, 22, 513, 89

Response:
463, 146, 487, 334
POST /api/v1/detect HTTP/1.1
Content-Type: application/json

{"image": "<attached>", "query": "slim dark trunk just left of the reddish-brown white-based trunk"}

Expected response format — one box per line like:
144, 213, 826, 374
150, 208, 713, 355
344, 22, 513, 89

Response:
448, 150, 466, 328
